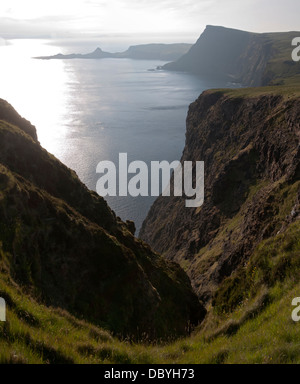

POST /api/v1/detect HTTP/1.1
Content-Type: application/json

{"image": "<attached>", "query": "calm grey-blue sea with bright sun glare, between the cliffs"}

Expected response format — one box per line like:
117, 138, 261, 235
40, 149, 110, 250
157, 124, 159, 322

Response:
0, 40, 225, 231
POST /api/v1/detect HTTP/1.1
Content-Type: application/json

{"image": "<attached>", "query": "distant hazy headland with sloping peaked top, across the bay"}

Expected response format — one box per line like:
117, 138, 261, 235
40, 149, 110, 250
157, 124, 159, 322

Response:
163, 25, 300, 86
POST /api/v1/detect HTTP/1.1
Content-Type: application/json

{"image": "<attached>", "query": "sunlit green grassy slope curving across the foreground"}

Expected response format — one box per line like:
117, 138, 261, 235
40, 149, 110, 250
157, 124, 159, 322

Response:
0, 216, 300, 364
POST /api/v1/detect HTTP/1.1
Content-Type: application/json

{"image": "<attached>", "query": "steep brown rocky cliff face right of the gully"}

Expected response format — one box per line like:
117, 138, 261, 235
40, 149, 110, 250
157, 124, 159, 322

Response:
140, 89, 300, 303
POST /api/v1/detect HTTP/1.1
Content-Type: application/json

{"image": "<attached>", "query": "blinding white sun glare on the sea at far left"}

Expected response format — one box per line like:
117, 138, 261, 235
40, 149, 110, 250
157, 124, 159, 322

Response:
0, 40, 70, 154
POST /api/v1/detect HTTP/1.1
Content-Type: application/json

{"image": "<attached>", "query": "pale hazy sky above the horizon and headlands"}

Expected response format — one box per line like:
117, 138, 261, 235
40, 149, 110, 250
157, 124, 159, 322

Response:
0, 0, 300, 42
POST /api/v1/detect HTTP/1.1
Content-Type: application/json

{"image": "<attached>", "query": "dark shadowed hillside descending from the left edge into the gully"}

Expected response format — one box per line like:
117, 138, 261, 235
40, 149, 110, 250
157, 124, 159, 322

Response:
0, 101, 205, 338
